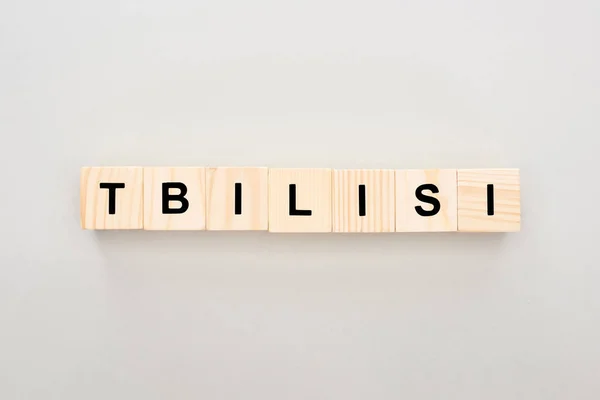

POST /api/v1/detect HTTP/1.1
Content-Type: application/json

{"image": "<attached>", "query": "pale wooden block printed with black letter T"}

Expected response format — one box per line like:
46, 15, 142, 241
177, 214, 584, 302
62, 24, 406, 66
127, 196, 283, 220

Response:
80, 167, 144, 229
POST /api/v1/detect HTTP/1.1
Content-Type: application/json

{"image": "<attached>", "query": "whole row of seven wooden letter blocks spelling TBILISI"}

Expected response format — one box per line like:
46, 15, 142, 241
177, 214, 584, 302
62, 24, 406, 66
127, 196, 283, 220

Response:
81, 167, 521, 232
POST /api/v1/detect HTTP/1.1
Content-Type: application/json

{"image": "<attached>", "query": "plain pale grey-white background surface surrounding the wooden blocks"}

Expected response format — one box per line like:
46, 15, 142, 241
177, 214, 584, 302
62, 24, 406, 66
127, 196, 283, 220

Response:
0, 0, 600, 400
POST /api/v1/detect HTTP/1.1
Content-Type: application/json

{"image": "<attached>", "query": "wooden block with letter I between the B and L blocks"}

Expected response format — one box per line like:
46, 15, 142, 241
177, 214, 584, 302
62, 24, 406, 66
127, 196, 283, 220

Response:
206, 167, 269, 231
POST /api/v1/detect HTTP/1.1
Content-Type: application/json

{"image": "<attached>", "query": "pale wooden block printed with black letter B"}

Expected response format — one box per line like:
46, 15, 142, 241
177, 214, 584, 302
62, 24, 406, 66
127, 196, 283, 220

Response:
144, 167, 206, 231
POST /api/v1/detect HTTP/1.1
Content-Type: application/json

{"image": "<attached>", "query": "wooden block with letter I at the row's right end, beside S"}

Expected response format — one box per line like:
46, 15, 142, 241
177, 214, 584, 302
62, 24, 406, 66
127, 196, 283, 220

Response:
458, 169, 521, 232
